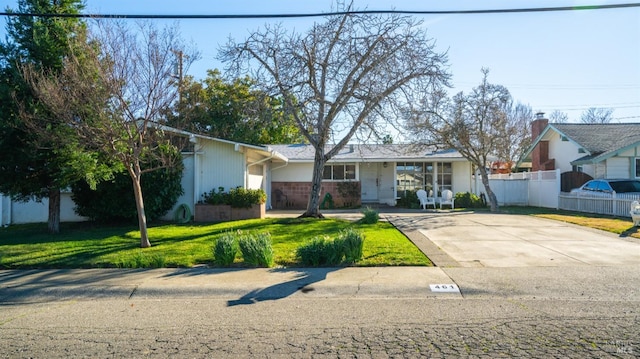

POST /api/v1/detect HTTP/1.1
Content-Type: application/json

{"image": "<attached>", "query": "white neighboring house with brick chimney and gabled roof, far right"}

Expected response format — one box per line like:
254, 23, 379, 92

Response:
523, 113, 640, 190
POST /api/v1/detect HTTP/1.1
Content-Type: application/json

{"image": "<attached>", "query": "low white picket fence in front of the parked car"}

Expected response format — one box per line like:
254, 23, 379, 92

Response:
558, 192, 640, 217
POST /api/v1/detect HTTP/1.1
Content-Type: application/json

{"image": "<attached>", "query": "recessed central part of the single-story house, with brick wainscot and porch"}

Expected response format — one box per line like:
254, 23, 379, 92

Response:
268, 144, 472, 209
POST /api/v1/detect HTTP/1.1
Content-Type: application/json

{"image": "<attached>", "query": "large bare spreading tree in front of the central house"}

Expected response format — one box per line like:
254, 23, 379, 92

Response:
220, 5, 450, 217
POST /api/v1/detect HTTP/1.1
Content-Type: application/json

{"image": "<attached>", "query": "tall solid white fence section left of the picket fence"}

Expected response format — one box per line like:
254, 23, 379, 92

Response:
476, 170, 560, 208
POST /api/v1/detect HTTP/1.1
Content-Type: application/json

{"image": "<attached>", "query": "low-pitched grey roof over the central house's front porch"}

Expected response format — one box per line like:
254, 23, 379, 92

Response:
267, 144, 466, 162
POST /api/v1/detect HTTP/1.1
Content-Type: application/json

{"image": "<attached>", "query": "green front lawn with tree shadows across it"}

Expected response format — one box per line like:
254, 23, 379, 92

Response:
0, 218, 431, 268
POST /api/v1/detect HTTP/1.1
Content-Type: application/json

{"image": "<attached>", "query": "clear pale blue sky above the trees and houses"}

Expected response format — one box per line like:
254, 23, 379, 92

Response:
0, 0, 640, 123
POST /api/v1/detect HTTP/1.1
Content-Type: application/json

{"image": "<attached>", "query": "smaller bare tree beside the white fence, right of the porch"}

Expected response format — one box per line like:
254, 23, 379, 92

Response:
407, 69, 533, 211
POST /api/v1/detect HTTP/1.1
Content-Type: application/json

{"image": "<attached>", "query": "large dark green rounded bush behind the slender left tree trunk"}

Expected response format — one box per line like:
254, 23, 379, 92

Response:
71, 161, 183, 223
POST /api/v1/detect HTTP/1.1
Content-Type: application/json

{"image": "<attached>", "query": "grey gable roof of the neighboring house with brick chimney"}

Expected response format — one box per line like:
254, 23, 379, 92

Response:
523, 123, 640, 165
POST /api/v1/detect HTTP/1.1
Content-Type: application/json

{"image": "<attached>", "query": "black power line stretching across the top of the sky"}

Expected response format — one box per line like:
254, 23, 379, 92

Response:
0, 3, 640, 20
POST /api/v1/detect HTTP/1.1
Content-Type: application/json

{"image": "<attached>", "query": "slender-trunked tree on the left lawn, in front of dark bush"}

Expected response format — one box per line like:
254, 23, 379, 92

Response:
23, 23, 197, 248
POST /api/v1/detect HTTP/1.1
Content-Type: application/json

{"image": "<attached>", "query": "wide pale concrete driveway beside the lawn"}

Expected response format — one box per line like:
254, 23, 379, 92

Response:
385, 212, 640, 267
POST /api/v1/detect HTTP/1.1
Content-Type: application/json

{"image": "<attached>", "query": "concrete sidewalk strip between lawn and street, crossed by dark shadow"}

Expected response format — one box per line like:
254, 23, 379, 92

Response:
0, 267, 461, 303
